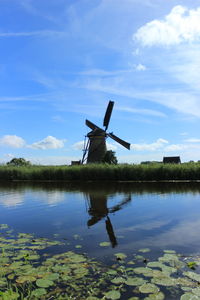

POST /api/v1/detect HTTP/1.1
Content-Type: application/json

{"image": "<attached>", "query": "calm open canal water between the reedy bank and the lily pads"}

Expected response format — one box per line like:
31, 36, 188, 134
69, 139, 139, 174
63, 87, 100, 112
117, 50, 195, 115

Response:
0, 183, 200, 300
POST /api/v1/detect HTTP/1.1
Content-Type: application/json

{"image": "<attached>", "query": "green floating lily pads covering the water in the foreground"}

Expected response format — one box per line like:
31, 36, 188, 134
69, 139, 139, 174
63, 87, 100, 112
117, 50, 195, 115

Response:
0, 224, 200, 300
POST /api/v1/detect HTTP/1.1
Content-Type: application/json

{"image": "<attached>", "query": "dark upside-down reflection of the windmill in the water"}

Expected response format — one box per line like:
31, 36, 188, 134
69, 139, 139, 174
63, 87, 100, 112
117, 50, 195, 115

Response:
86, 192, 131, 248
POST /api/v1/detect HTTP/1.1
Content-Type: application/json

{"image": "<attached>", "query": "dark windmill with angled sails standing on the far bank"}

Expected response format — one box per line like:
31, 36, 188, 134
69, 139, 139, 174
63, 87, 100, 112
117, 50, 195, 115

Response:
82, 101, 130, 163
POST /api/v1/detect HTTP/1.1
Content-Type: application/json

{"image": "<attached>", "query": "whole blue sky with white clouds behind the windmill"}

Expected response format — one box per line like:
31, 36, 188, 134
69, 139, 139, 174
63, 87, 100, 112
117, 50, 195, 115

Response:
0, 0, 200, 165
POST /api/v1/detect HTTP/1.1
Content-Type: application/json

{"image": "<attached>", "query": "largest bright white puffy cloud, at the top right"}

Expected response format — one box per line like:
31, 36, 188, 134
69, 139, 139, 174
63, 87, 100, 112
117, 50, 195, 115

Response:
133, 5, 200, 46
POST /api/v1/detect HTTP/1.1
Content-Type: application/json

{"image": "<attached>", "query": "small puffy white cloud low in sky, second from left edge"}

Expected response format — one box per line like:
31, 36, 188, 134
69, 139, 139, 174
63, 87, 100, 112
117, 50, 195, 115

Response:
29, 135, 64, 150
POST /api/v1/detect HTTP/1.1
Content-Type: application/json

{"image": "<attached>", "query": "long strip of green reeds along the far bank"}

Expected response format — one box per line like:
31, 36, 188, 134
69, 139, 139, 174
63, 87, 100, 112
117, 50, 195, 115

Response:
0, 163, 200, 181
